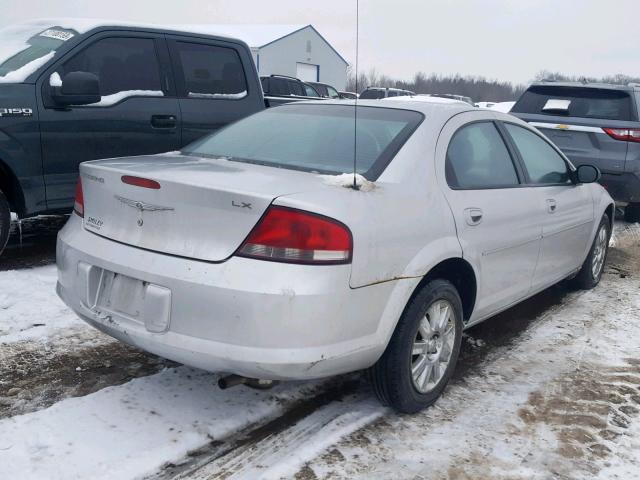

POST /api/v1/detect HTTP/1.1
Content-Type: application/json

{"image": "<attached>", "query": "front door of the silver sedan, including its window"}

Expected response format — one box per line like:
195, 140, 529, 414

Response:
503, 122, 594, 289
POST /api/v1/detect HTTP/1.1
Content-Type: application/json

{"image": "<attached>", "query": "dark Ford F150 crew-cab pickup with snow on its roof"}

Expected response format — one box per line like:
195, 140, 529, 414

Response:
0, 19, 308, 252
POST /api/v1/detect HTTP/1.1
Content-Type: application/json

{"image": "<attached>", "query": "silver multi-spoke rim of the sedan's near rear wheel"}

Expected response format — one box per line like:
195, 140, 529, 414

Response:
411, 300, 456, 393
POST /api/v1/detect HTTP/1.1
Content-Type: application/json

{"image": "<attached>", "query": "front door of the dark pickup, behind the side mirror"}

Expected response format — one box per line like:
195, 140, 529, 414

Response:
37, 32, 180, 210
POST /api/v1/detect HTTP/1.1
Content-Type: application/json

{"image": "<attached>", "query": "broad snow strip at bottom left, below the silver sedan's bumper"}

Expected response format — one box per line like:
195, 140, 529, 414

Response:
0, 367, 328, 480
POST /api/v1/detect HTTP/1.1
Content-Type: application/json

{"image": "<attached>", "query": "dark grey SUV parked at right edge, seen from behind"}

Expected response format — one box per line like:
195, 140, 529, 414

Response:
511, 82, 640, 222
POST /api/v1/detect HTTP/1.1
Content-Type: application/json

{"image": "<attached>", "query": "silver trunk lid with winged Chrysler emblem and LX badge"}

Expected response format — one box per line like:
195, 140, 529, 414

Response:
80, 154, 322, 262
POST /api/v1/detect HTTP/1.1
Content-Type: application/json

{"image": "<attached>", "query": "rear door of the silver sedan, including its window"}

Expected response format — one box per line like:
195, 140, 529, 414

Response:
437, 112, 542, 321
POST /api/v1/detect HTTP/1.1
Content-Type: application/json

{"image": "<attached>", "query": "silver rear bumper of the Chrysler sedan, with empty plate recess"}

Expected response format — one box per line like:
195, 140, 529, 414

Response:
57, 215, 394, 380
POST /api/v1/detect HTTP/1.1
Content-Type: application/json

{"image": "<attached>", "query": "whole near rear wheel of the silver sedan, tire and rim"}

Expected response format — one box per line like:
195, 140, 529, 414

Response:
369, 280, 463, 413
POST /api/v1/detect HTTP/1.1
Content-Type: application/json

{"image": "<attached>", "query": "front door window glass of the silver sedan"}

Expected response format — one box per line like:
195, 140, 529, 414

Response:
504, 123, 569, 184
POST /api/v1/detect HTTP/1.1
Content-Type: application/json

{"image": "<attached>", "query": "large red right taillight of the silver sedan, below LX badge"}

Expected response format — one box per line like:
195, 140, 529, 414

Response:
237, 206, 353, 264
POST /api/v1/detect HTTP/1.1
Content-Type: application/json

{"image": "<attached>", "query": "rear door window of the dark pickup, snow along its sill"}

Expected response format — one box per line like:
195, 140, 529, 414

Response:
175, 42, 247, 98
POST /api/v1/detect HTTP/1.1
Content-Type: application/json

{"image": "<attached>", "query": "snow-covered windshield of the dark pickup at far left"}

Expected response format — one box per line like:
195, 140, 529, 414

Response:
0, 23, 77, 83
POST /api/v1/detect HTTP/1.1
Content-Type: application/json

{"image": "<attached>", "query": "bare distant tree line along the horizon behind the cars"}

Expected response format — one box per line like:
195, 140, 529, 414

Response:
347, 69, 640, 102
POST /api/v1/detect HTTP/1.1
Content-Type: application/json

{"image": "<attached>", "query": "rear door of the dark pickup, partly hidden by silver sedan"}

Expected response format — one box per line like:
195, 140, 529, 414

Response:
167, 35, 264, 146
